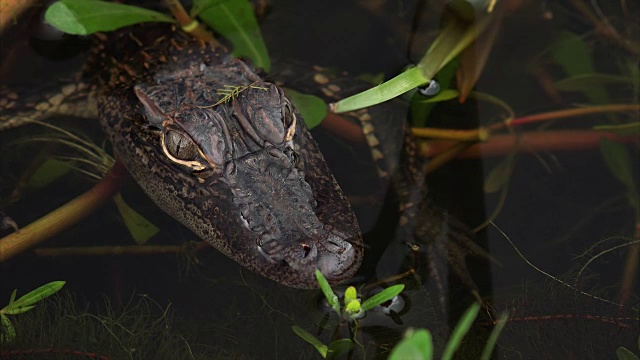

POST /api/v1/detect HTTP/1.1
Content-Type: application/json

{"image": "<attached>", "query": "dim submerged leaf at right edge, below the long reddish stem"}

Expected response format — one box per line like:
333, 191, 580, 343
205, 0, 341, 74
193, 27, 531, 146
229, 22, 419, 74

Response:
600, 138, 640, 213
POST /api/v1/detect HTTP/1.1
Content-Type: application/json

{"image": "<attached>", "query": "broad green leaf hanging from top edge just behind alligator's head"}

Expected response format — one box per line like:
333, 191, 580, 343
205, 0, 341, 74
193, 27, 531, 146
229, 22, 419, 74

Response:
199, 0, 271, 72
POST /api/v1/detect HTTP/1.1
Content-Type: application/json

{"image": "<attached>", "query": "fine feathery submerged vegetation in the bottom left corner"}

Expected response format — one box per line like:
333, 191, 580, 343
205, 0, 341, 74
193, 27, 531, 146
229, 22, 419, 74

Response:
0, 294, 236, 360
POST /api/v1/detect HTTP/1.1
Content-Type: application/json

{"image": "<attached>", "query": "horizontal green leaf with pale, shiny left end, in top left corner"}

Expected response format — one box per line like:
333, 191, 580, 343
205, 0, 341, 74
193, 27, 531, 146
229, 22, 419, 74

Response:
44, 0, 174, 35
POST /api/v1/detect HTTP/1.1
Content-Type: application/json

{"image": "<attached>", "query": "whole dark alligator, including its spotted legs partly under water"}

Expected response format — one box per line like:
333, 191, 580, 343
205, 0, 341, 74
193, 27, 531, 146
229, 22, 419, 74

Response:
0, 24, 486, 289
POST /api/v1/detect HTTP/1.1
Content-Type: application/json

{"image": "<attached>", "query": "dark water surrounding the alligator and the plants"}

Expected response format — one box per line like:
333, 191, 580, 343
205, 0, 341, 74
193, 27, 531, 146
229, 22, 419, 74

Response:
0, 1, 640, 359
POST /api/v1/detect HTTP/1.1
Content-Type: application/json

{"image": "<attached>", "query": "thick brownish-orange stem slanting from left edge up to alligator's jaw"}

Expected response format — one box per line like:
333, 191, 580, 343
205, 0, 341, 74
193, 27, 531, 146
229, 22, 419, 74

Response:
0, 160, 126, 263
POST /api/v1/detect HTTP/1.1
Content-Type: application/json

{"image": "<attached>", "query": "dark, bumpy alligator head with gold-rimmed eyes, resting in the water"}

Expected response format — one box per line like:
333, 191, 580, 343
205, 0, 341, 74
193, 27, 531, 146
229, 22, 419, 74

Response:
100, 48, 363, 288
